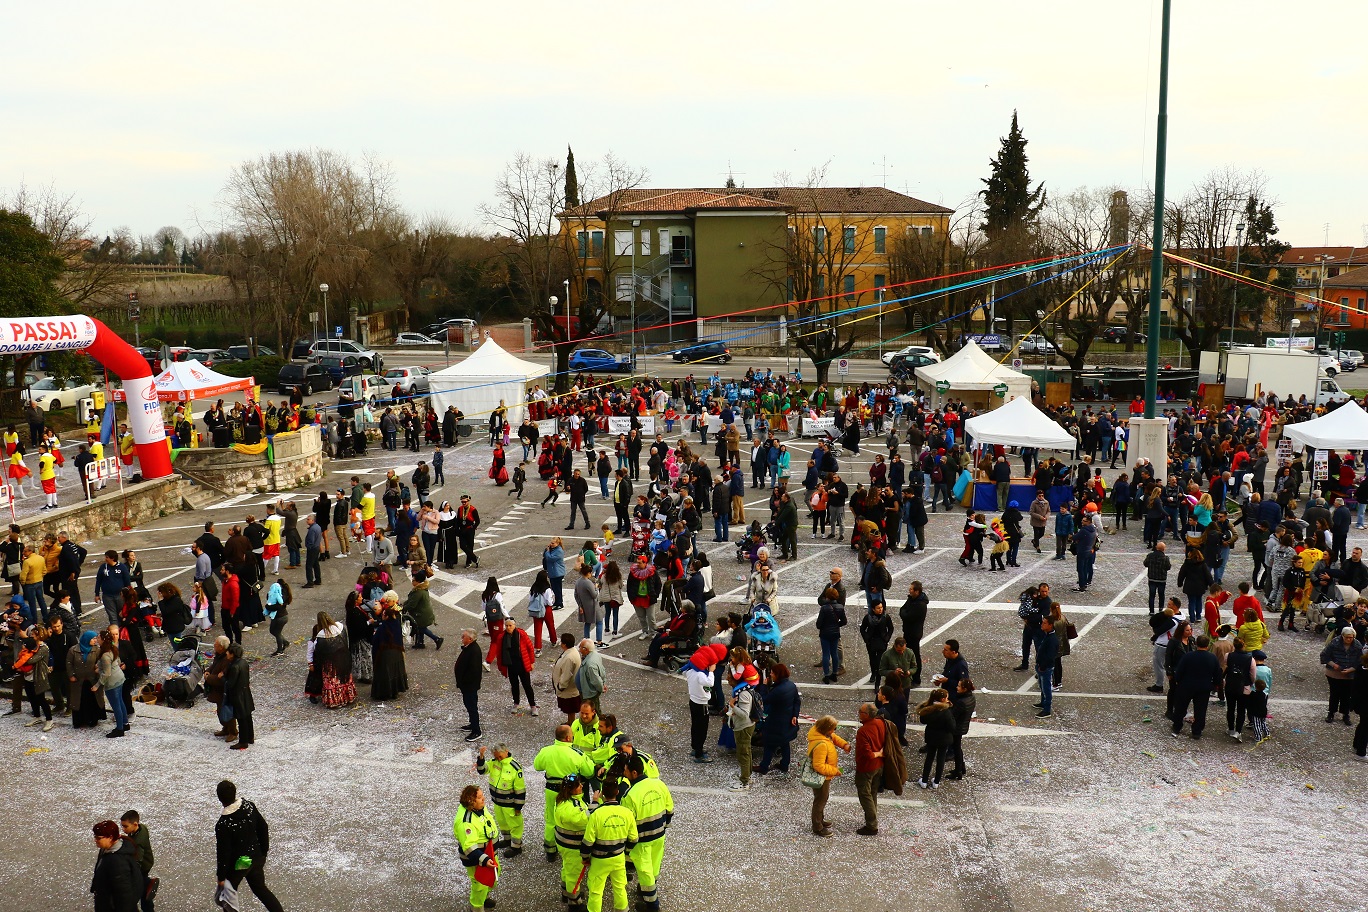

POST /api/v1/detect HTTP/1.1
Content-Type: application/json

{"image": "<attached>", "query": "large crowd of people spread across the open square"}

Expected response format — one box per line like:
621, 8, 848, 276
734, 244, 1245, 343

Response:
16, 360, 1368, 911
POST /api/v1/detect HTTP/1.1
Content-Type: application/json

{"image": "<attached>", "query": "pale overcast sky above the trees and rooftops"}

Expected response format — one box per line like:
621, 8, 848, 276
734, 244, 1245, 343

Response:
0, 0, 1368, 245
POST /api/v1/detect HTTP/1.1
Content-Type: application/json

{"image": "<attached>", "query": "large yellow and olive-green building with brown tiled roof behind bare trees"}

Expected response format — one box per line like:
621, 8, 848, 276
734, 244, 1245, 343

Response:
561, 187, 953, 328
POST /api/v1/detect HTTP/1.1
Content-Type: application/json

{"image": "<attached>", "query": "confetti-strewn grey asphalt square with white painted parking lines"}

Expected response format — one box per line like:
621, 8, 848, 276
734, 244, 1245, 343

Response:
0, 429, 1368, 912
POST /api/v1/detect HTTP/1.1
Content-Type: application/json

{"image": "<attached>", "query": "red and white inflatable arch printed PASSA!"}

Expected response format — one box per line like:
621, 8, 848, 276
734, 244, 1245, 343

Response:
0, 316, 171, 479
